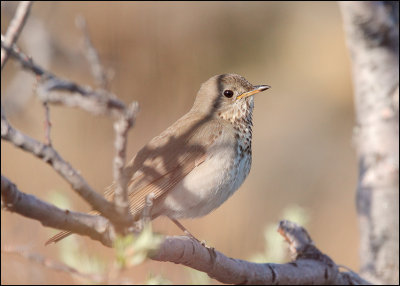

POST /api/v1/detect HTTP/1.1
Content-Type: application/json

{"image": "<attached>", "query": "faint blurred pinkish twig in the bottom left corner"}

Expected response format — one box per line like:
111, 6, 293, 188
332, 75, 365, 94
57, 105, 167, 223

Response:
1, 245, 106, 283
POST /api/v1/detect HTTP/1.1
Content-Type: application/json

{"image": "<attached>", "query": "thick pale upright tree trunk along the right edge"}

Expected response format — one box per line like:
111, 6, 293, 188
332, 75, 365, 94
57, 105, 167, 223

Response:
340, 1, 399, 284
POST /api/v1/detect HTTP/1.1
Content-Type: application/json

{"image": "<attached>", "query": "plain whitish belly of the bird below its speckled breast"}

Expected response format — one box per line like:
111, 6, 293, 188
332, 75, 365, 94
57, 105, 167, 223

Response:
157, 140, 251, 219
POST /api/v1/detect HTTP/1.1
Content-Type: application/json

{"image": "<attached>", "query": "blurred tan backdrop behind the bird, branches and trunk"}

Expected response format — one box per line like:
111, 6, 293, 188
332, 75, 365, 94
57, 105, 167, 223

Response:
1, 1, 359, 284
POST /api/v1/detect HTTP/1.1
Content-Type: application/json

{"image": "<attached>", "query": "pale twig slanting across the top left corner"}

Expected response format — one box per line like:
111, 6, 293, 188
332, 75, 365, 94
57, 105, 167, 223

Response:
1, 1, 33, 69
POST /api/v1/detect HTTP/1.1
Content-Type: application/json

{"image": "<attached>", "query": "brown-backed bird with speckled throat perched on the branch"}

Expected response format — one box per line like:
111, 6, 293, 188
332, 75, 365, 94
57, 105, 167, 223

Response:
46, 73, 270, 245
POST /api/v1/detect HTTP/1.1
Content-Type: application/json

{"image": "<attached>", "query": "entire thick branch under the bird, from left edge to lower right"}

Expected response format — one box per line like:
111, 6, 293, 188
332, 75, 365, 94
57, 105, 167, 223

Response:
1, 176, 369, 285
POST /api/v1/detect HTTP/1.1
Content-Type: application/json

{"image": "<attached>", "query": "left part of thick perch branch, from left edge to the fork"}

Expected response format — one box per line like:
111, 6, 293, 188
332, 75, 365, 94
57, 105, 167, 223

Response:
1, 176, 114, 246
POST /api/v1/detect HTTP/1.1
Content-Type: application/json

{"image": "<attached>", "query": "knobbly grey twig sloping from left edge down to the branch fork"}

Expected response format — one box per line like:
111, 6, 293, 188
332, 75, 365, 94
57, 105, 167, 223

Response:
1, 109, 115, 220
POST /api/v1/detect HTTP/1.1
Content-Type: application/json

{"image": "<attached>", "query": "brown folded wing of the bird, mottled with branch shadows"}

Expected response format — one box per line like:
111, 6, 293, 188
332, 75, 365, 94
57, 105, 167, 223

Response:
107, 111, 222, 216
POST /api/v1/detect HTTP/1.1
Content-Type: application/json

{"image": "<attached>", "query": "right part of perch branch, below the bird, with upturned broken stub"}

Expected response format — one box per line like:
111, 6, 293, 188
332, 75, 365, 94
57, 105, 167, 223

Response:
151, 221, 370, 285
